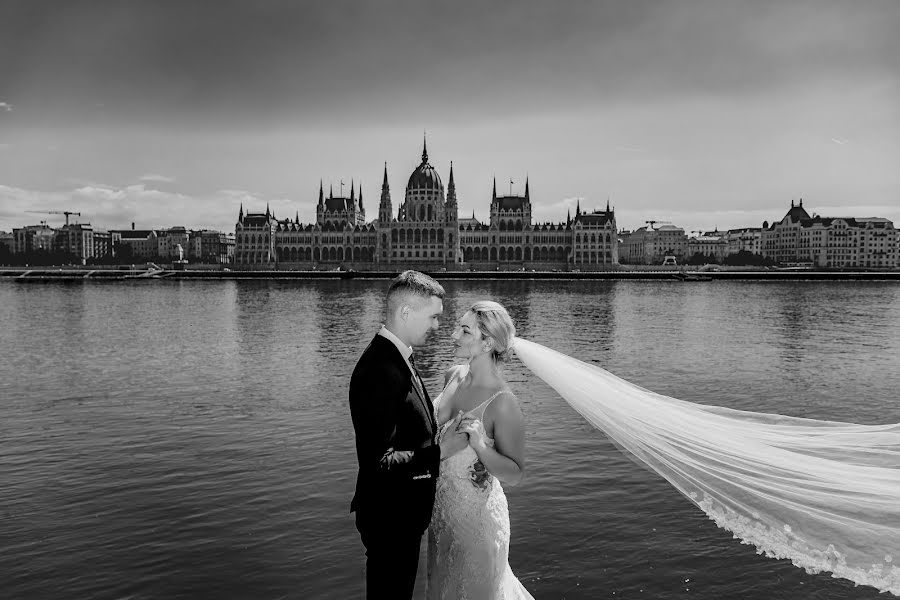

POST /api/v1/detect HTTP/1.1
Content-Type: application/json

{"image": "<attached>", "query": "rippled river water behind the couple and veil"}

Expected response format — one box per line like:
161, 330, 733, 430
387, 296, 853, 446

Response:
0, 280, 900, 600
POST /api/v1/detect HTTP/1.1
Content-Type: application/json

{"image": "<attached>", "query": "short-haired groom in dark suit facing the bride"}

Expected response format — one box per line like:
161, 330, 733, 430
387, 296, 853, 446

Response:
350, 271, 467, 598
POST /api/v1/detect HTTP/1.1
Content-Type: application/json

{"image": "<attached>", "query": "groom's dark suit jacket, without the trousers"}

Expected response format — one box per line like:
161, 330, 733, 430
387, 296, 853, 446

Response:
350, 335, 441, 532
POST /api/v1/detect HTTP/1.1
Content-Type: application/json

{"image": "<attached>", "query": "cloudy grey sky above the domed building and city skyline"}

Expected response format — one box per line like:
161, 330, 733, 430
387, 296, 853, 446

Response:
0, 0, 900, 231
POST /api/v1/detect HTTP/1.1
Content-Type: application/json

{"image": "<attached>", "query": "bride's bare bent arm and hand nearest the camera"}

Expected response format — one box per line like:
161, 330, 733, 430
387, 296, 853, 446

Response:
459, 393, 525, 485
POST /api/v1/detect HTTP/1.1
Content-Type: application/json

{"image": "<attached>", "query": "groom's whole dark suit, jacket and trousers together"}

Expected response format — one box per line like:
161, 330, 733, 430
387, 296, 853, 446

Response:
350, 335, 441, 598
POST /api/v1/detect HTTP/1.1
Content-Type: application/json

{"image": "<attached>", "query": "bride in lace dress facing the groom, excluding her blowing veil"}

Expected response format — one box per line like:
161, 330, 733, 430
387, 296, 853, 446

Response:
426, 301, 532, 600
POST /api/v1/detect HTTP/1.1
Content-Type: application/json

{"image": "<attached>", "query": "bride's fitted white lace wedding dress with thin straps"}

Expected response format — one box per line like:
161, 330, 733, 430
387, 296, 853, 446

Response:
426, 370, 533, 600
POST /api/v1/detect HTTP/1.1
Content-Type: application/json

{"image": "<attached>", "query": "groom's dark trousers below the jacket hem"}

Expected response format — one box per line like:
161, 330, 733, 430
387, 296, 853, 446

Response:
356, 513, 422, 600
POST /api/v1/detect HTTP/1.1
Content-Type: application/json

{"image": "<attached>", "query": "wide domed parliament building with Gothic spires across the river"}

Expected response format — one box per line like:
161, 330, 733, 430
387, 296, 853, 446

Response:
234, 139, 618, 271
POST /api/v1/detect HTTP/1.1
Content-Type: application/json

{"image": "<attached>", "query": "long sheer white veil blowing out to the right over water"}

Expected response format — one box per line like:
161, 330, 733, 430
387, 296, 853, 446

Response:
515, 338, 900, 596
